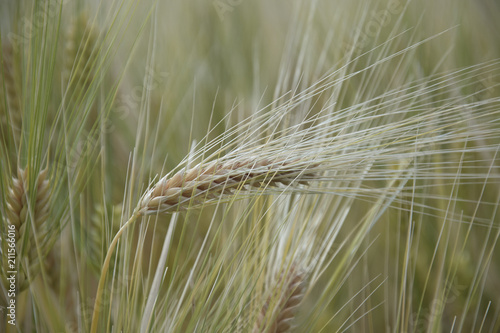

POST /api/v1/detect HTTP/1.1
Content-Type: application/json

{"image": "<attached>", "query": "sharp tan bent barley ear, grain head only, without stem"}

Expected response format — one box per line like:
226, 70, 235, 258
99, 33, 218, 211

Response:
139, 158, 317, 215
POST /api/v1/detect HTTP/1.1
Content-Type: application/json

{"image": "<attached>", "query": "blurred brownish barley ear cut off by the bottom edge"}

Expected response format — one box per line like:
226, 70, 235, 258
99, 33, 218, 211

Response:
252, 266, 305, 333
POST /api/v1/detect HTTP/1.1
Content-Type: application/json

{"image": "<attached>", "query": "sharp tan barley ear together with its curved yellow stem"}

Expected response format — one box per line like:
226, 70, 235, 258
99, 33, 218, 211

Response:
91, 159, 314, 333
